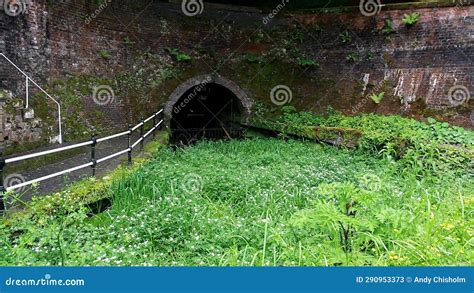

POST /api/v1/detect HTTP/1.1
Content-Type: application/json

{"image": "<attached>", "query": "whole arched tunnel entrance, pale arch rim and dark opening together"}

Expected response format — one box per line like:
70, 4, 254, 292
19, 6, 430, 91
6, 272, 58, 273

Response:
165, 76, 250, 144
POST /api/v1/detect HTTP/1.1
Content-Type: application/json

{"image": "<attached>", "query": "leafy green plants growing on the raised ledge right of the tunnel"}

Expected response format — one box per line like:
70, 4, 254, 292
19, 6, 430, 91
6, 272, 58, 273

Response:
255, 108, 474, 176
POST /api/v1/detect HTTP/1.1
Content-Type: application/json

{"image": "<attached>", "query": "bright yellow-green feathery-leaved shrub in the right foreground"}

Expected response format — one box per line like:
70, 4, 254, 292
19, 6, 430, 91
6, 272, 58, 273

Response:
287, 173, 472, 265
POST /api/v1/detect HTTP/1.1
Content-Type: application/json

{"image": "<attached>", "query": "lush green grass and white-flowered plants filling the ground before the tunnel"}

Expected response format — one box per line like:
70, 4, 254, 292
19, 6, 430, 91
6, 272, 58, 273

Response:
0, 135, 474, 266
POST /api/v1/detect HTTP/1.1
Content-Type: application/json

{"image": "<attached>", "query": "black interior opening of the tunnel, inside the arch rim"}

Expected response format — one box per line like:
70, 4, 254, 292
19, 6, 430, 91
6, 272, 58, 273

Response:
170, 83, 242, 145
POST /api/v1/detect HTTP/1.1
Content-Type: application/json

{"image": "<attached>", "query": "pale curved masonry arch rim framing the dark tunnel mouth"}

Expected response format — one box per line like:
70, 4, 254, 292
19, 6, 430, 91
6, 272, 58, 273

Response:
164, 74, 253, 126
